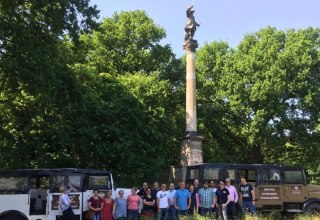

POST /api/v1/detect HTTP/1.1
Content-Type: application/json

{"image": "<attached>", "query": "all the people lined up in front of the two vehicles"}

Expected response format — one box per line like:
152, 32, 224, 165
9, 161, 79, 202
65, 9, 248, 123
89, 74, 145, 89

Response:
61, 177, 256, 220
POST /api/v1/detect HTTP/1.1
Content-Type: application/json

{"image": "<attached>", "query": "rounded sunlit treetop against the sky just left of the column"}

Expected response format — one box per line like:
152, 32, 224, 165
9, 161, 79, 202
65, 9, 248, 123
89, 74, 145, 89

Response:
77, 10, 174, 74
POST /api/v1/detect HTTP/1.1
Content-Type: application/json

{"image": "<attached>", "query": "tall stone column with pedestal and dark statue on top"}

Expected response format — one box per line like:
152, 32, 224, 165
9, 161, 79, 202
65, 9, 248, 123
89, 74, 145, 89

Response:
181, 5, 203, 180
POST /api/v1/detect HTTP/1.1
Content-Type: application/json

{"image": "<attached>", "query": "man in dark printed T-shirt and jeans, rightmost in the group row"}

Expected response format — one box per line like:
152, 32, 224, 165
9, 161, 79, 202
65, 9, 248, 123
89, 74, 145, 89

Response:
240, 176, 257, 215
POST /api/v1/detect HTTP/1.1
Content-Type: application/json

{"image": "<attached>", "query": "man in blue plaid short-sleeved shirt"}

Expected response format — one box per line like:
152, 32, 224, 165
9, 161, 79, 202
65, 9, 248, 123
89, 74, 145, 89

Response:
198, 181, 216, 218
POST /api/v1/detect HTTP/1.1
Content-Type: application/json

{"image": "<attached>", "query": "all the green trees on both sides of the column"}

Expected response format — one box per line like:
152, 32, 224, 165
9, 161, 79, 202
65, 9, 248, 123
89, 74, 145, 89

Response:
0, 0, 320, 185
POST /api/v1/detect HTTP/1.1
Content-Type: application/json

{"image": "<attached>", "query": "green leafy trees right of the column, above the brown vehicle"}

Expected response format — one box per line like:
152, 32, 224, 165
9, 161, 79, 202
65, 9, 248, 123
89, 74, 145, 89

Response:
197, 27, 320, 180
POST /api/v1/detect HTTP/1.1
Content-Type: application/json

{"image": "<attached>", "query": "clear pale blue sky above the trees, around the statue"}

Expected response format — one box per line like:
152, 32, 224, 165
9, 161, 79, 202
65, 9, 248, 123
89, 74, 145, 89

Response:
91, 0, 320, 57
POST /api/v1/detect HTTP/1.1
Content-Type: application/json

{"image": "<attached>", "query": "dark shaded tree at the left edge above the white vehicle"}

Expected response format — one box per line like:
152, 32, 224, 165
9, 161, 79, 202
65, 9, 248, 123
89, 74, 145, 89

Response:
0, 0, 98, 168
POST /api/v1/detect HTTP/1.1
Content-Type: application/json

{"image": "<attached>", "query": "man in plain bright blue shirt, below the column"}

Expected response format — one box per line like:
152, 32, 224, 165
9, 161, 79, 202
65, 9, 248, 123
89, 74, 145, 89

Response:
174, 182, 191, 216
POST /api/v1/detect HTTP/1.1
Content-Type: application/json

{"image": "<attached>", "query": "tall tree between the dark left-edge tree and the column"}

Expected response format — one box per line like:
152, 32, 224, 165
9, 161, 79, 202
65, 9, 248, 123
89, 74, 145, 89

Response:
71, 11, 183, 185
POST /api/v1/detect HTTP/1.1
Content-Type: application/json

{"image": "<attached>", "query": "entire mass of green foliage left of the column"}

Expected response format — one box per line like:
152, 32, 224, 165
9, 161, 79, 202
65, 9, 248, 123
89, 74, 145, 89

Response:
0, 3, 183, 185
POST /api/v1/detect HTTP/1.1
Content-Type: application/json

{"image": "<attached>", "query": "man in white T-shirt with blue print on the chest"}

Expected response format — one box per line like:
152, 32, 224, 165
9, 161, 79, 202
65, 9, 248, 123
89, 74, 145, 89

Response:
157, 184, 170, 220
